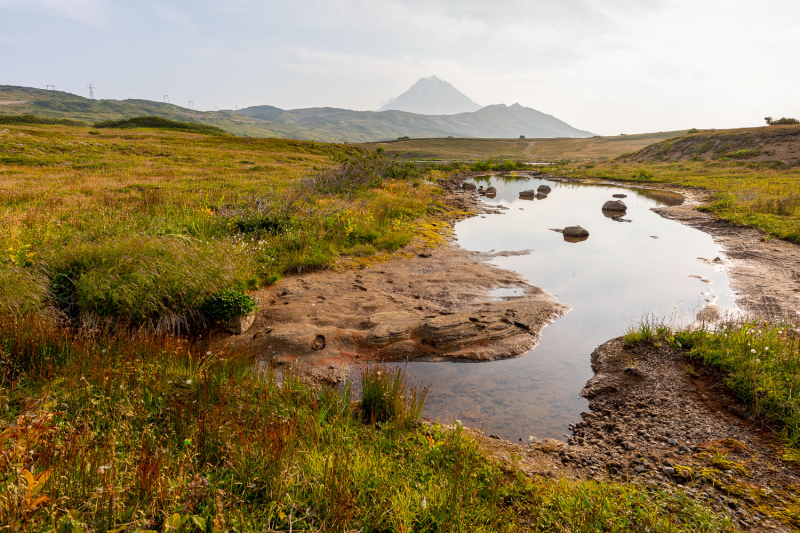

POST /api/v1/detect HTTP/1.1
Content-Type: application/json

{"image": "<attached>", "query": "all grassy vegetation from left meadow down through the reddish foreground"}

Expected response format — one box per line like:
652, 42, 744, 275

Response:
0, 125, 731, 533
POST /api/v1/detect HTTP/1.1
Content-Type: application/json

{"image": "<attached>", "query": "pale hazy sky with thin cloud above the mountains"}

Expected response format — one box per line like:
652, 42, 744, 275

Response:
0, 0, 800, 135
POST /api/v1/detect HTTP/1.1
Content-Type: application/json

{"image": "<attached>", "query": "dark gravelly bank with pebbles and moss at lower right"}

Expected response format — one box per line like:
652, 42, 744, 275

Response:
473, 338, 800, 531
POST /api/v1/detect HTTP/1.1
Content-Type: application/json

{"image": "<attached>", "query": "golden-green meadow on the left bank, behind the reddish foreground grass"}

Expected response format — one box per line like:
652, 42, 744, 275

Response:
0, 126, 437, 327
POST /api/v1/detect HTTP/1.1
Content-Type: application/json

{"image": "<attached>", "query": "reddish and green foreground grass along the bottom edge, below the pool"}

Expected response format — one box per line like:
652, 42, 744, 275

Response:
0, 316, 731, 533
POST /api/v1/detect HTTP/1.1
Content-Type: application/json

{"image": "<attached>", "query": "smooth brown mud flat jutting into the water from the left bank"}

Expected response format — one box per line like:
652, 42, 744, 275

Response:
212, 175, 569, 381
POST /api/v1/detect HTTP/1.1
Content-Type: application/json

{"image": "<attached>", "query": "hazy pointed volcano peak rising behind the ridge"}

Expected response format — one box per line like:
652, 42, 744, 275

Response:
378, 76, 481, 115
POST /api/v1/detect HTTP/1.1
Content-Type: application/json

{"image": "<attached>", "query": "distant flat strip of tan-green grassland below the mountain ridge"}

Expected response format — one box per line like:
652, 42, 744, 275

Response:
356, 131, 686, 162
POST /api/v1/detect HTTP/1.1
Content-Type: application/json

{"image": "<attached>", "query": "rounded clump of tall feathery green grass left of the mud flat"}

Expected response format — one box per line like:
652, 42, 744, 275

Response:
48, 237, 255, 331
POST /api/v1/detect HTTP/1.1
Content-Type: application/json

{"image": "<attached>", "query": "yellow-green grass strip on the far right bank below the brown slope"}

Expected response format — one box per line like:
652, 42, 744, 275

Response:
552, 161, 800, 243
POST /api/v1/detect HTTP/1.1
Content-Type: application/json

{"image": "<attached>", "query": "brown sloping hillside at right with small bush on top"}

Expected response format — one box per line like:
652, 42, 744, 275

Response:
619, 125, 800, 165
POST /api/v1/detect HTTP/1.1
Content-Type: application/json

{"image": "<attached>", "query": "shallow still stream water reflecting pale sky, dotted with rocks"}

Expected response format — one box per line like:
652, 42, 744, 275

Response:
394, 176, 735, 442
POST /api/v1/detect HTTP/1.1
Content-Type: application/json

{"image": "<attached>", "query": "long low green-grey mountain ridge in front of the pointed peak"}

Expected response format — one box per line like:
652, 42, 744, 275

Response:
0, 86, 593, 142
